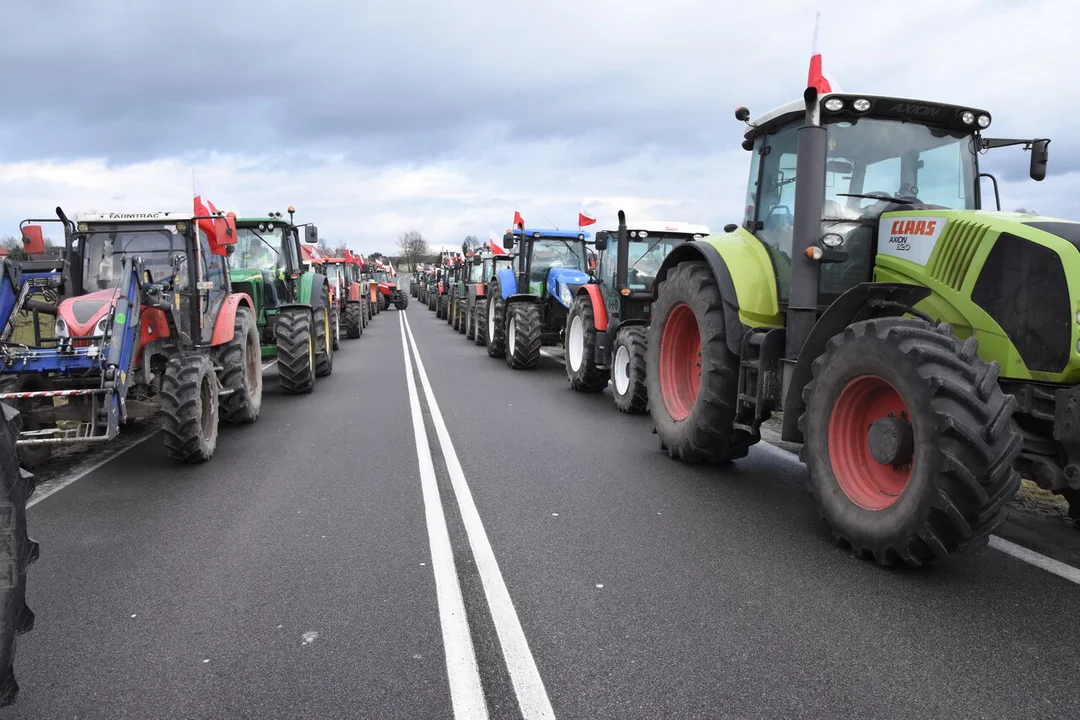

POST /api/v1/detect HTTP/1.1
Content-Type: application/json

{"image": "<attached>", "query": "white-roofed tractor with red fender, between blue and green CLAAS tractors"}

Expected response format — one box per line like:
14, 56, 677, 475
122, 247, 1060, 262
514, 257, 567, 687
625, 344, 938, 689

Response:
564, 210, 708, 415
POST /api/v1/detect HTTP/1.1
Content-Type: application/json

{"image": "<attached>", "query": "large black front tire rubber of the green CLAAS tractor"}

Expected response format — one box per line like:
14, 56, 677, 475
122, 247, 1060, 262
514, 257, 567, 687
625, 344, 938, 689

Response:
800, 317, 1022, 566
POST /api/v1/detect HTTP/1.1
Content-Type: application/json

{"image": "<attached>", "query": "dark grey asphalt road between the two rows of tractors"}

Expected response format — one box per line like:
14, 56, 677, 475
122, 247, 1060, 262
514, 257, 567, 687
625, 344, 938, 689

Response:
12, 282, 1080, 719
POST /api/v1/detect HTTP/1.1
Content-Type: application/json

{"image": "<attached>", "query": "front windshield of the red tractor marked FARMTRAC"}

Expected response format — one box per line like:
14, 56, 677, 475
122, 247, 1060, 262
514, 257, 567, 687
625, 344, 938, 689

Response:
81, 226, 188, 293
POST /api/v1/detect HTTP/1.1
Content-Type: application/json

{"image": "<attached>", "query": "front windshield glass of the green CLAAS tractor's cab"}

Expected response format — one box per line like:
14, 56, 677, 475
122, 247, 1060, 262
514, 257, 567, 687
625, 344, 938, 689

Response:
823, 118, 977, 220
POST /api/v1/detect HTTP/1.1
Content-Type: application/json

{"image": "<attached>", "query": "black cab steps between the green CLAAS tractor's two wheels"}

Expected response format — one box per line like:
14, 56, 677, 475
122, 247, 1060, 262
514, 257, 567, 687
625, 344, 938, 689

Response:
734, 327, 784, 439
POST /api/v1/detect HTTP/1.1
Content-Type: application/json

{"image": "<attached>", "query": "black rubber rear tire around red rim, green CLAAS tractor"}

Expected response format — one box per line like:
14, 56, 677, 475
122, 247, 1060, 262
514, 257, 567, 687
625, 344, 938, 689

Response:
645, 261, 757, 463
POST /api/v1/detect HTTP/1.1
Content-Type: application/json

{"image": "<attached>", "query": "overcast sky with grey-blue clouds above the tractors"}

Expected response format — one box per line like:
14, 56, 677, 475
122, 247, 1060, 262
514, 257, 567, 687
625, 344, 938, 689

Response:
0, 0, 1080, 252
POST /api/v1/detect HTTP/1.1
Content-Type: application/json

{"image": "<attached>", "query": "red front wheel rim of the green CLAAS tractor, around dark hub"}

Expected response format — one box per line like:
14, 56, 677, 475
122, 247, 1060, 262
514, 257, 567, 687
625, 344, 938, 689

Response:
828, 375, 914, 511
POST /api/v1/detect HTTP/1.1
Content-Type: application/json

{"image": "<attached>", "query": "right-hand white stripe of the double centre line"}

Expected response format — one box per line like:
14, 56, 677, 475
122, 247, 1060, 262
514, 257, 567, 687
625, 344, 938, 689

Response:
402, 315, 555, 720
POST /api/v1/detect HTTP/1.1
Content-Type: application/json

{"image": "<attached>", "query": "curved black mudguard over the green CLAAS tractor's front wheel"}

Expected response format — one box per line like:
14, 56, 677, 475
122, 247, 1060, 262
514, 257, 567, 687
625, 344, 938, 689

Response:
781, 283, 930, 443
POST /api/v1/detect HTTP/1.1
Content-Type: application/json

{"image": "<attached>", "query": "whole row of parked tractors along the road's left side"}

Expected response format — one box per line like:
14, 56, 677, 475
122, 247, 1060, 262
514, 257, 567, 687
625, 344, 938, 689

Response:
0, 198, 408, 704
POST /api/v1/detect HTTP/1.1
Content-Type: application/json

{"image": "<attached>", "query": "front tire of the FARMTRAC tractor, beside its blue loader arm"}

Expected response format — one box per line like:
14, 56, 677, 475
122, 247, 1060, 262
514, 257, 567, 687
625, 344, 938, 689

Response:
161, 352, 220, 463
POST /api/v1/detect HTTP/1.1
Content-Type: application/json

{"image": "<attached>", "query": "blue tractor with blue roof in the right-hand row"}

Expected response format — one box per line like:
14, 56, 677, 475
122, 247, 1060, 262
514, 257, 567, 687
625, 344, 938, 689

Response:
487, 225, 590, 370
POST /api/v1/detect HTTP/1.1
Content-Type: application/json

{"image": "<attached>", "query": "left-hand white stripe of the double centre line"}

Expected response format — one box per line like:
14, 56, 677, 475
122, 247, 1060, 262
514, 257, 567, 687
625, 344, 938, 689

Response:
397, 313, 488, 720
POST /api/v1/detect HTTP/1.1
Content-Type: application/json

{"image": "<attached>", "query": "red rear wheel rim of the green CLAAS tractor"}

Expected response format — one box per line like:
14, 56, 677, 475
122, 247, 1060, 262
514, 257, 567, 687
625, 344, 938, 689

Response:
660, 302, 701, 420
